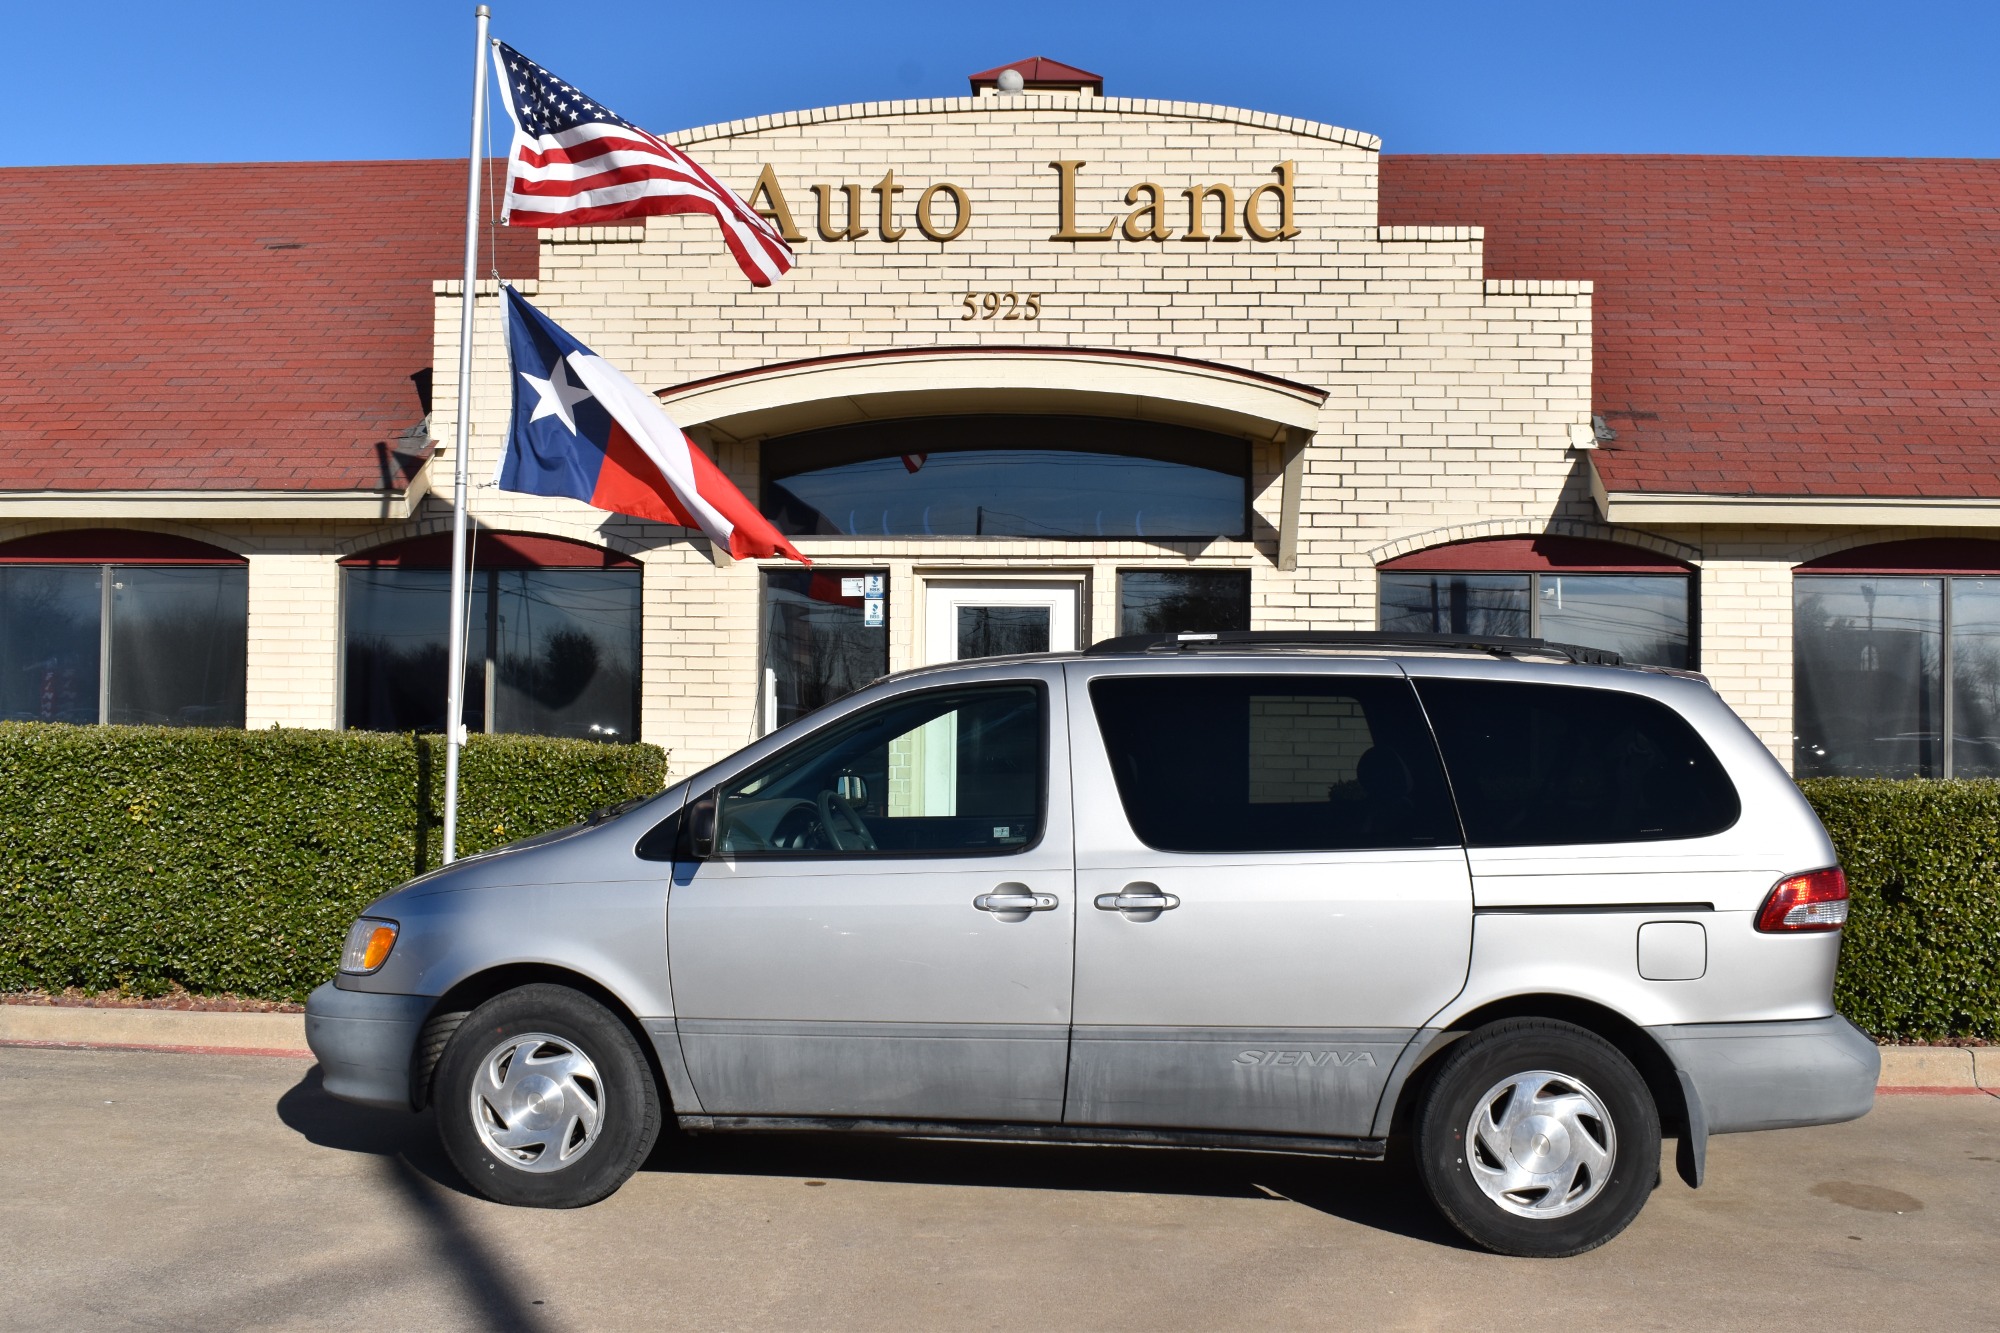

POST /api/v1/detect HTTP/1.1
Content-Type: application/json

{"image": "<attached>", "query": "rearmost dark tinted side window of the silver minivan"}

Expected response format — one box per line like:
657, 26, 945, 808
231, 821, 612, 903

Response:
1416, 681, 1742, 847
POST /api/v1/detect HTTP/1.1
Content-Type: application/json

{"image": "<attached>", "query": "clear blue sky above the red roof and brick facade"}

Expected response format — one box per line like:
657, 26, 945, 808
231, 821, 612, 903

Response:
15, 0, 2000, 166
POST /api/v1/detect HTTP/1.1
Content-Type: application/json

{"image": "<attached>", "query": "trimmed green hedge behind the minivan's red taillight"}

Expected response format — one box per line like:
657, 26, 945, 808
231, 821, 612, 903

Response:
1800, 779, 2000, 1041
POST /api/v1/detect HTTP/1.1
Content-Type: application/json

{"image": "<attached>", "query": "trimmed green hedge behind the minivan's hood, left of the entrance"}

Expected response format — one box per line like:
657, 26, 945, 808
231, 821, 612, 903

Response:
0, 723, 666, 999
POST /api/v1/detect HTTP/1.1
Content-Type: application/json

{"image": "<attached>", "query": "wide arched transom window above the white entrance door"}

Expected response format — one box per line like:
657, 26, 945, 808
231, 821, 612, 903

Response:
764, 416, 1250, 540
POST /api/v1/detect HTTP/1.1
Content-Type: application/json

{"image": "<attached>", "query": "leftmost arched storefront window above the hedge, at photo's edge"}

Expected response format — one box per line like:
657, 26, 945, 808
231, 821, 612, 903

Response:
0, 532, 250, 727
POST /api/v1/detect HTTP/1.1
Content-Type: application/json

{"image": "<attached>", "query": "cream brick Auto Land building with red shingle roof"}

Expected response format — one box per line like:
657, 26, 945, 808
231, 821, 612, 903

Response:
0, 62, 2000, 777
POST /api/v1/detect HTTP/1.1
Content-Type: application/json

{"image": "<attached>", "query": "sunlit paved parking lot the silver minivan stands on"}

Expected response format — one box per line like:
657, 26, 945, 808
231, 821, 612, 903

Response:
0, 1049, 2000, 1331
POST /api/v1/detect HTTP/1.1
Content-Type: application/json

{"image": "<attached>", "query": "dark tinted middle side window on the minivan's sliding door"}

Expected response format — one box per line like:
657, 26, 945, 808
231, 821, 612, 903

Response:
1090, 675, 1458, 853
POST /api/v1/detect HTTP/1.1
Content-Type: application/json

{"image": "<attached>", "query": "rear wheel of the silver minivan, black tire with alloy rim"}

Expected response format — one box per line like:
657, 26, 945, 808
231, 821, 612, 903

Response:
1416, 1019, 1660, 1259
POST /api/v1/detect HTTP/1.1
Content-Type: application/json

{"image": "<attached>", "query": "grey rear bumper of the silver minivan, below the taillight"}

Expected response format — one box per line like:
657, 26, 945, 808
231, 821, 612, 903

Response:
1646, 1015, 1882, 1135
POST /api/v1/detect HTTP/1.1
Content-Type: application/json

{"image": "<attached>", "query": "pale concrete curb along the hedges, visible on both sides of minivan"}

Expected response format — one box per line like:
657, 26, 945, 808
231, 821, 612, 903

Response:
0, 1005, 2000, 1095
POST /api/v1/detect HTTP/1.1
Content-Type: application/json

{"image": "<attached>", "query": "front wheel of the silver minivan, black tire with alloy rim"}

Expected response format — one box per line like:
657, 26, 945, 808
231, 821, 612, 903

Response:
432, 985, 660, 1209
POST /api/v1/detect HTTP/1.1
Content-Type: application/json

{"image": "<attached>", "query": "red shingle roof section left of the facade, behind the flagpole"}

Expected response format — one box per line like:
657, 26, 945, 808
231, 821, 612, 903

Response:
0, 162, 538, 490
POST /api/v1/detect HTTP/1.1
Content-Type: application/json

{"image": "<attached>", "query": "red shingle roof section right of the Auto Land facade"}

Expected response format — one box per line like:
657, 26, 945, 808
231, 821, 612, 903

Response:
1380, 156, 2000, 498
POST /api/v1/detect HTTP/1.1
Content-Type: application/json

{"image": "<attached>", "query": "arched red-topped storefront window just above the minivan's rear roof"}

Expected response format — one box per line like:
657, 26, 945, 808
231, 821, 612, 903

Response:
1380, 536, 1694, 669
